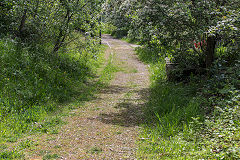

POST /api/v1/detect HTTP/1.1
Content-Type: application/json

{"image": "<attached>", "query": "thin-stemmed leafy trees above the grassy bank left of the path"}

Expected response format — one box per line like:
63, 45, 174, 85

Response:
0, 0, 102, 52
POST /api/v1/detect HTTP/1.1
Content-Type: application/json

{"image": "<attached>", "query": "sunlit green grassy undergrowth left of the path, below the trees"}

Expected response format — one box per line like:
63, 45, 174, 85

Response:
0, 33, 111, 159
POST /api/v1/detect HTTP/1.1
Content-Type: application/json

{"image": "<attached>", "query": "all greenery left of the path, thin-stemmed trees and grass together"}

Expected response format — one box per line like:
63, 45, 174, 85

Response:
0, 0, 108, 159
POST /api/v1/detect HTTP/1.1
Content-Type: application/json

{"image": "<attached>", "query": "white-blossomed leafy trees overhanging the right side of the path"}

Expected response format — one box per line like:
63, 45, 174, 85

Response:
105, 0, 240, 71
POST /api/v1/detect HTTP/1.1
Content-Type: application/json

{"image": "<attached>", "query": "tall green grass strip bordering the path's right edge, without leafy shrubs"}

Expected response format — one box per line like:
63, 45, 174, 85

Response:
137, 48, 203, 159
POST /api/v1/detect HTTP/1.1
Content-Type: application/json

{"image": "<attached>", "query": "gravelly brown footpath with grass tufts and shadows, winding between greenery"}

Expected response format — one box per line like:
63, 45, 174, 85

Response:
28, 35, 149, 160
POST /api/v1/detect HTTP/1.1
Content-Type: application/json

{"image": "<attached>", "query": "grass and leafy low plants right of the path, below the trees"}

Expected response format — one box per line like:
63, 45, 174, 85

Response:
137, 48, 240, 159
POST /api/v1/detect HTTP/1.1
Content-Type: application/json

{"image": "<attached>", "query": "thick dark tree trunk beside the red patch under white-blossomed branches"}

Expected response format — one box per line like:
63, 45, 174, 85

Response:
205, 36, 216, 68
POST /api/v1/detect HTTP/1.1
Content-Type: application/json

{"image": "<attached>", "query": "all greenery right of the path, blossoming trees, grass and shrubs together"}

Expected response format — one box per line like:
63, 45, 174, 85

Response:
104, 0, 240, 159
